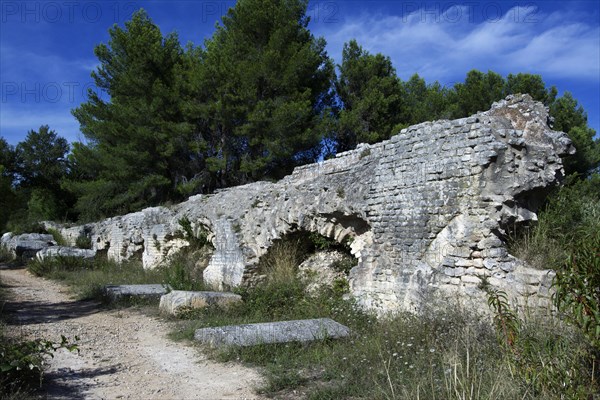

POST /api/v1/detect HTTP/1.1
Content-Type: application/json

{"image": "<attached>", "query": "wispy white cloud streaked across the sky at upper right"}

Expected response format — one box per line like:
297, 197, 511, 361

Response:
313, 7, 600, 84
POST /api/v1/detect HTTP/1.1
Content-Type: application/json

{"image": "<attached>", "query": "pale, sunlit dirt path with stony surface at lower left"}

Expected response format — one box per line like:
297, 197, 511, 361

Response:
0, 268, 261, 399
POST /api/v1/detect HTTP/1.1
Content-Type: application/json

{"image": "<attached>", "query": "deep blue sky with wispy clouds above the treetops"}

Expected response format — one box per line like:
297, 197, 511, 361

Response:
0, 0, 600, 144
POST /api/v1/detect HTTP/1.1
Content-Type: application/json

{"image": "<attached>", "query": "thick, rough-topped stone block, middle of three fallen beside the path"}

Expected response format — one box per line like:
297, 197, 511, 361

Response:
158, 290, 242, 315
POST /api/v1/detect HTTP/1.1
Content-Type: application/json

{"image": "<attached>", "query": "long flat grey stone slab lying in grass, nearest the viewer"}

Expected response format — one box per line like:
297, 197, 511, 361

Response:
194, 318, 350, 346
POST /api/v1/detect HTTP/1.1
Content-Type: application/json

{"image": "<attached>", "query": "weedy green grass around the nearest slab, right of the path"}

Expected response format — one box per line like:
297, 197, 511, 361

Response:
172, 238, 600, 400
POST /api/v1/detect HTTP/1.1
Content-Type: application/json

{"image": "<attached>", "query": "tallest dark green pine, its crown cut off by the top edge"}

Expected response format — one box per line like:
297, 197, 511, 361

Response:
198, 0, 333, 186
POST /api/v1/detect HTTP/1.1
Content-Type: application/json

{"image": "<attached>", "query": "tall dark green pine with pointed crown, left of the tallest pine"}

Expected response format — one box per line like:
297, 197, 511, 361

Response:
69, 10, 192, 219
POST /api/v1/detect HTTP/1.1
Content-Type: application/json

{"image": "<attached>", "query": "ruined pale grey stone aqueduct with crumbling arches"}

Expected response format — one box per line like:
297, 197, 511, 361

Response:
45, 95, 574, 312
